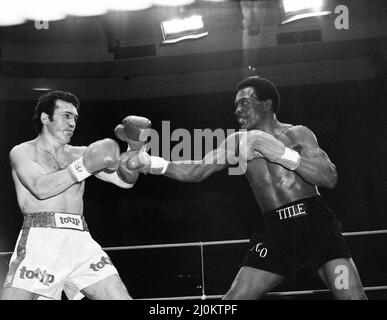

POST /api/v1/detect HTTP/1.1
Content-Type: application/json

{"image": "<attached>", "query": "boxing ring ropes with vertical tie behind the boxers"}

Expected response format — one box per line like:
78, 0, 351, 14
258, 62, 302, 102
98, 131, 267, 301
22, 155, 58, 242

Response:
0, 230, 387, 300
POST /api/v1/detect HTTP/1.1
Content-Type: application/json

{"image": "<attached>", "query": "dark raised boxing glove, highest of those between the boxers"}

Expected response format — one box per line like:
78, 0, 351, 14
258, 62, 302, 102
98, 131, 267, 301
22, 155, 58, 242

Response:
114, 116, 152, 150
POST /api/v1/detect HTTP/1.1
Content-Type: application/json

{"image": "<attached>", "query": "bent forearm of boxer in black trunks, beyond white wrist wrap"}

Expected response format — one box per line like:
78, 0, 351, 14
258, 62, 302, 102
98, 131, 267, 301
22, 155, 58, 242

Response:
296, 157, 337, 189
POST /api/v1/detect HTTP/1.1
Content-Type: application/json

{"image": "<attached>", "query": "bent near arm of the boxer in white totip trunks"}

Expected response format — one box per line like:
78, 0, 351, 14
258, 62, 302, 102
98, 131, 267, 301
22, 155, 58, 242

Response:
9, 145, 79, 200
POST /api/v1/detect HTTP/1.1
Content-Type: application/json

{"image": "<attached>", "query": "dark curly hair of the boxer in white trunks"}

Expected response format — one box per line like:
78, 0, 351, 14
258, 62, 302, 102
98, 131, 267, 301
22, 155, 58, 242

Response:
32, 90, 80, 133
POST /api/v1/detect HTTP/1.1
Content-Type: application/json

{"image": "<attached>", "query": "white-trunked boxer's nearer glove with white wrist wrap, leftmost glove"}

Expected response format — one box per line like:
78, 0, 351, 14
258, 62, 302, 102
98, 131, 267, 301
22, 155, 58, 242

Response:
69, 139, 120, 182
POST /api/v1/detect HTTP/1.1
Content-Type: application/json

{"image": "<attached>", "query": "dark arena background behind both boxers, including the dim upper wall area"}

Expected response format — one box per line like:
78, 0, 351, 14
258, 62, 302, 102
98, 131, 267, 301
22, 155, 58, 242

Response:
0, 0, 387, 298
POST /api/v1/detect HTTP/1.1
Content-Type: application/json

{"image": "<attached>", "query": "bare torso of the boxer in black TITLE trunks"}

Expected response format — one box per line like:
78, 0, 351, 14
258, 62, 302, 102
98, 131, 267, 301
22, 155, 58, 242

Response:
246, 125, 319, 213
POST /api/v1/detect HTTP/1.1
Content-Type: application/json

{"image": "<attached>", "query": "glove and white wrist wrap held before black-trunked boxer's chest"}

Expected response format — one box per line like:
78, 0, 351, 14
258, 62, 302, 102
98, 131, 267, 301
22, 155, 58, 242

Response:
239, 130, 301, 170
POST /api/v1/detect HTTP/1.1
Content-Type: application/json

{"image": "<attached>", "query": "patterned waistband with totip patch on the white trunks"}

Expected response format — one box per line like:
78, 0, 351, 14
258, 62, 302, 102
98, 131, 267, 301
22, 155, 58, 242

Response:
22, 212, 89, 231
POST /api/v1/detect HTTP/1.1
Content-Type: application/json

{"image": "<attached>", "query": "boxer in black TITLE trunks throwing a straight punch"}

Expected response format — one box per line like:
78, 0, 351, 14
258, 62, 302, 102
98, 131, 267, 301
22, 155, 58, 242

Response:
126, 76, 367, 300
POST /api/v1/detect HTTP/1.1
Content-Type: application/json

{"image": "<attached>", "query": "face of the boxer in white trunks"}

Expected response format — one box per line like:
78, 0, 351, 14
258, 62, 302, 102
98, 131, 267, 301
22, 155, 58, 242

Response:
46, 100, 78, 144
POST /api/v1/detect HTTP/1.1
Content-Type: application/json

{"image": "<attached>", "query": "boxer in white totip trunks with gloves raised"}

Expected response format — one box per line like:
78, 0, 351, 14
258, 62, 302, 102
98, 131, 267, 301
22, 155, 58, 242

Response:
2, 91, 149, 300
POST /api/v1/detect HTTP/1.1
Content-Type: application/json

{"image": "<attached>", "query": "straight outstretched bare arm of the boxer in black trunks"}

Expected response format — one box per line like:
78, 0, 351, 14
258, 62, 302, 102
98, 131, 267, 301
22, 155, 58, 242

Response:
164, 134, 238, 182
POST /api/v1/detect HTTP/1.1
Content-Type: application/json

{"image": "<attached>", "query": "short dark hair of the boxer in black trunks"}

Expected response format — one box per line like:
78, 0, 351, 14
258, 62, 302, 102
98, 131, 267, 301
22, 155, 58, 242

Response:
237, 76, 281, 114
